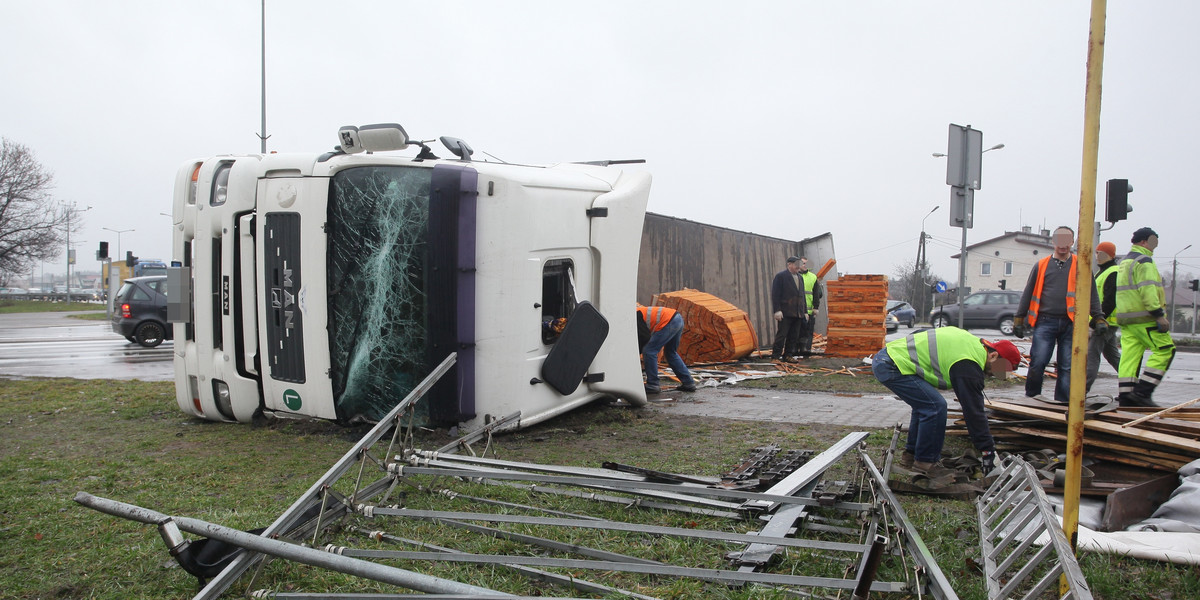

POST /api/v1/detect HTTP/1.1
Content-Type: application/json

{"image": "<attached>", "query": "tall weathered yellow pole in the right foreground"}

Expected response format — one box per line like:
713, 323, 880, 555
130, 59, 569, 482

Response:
1062, 0, 1106, 566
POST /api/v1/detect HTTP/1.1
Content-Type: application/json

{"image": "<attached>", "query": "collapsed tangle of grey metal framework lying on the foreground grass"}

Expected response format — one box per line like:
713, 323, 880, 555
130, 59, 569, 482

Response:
79, 355, 956, 600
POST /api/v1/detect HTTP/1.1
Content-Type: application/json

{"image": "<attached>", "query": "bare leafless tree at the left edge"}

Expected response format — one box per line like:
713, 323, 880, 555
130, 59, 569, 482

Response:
0, 138, 72, 276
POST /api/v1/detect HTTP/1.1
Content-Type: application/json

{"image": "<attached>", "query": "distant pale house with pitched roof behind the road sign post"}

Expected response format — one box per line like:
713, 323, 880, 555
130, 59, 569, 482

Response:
948, 226, 1054, 292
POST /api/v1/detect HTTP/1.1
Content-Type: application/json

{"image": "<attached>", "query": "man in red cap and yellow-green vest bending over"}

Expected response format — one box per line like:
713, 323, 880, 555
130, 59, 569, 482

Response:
871, 328, 1021, 479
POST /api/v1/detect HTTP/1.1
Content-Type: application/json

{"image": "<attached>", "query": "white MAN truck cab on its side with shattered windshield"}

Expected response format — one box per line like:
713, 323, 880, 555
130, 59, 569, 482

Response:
168, 124, 650, 428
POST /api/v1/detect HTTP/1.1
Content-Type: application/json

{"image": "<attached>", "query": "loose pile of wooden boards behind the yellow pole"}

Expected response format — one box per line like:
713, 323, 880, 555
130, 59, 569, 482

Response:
954, 398, 1200, 473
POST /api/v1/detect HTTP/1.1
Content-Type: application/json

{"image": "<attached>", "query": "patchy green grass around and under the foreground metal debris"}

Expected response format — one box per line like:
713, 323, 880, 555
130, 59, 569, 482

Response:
0, 379, 1200, 600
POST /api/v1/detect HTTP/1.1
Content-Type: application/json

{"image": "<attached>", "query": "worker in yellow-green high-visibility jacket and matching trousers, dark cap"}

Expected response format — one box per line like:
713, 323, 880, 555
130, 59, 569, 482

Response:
1116, 227, 1175, 407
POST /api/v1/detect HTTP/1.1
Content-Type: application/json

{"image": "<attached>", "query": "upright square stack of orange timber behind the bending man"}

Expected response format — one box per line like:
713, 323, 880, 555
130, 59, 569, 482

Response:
824, 275, 888, 358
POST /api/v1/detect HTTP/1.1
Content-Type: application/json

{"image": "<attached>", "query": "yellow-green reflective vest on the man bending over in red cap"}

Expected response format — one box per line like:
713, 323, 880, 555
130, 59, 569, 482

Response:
884, 328, 988, 390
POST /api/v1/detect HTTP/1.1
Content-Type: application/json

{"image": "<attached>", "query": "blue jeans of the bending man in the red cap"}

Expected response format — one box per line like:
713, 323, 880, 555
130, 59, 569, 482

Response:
871, 348, 946, 462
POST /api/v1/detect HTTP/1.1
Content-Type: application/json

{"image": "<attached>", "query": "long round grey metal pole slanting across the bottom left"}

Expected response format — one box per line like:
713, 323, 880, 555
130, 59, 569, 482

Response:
74, 492, 511, 596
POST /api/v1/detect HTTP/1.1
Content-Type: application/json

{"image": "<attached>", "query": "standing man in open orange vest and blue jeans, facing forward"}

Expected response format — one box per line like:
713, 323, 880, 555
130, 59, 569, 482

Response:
1013, 226, 1108, 404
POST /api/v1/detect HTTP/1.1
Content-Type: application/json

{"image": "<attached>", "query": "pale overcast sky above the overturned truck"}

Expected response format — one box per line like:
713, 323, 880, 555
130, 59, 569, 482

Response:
0, 0, 1200, 280
